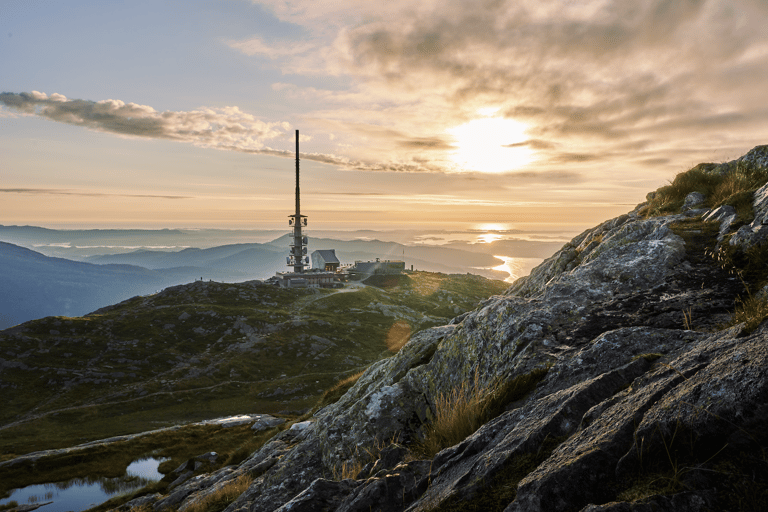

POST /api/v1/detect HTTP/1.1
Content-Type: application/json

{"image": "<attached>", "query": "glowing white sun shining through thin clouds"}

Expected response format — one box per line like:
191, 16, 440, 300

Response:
448, 117, 534, 173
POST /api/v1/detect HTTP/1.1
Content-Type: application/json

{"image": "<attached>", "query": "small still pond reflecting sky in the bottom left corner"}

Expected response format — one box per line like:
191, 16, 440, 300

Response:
0, 458, 167, 512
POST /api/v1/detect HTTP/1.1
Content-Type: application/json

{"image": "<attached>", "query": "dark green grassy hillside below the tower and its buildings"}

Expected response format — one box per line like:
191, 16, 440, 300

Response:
0, 272, 507, 460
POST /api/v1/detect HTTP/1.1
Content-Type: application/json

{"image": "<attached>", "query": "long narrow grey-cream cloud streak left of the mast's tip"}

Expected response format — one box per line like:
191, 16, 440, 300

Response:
0, 91, 289, 150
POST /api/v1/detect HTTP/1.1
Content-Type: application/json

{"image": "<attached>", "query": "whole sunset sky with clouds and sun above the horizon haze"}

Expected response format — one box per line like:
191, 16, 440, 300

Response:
0, 0, 768, 236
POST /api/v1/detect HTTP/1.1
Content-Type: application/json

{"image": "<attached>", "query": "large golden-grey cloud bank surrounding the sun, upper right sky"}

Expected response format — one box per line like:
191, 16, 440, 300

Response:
248, 0, 768, 176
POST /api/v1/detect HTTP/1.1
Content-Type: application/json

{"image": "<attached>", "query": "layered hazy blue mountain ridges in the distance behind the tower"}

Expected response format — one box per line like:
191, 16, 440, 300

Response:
0, 227, 528, 329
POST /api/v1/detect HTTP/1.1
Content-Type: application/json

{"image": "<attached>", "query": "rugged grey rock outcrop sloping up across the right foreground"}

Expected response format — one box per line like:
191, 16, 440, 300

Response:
140, 147, 768, 512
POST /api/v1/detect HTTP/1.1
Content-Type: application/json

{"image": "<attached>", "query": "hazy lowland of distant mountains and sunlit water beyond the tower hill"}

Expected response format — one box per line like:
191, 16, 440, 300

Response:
0, 226, 562, 329
